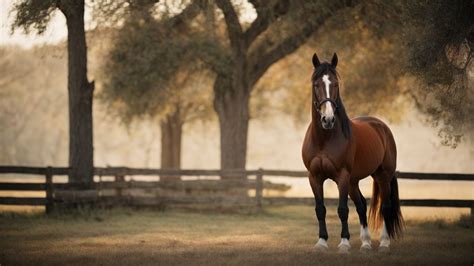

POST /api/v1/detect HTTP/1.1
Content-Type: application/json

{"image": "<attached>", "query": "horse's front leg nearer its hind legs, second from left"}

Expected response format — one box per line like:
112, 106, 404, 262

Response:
337, 171, 351, 253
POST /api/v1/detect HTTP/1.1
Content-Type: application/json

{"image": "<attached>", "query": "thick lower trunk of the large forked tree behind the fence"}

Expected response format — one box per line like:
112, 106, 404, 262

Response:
214, 76, 250, 176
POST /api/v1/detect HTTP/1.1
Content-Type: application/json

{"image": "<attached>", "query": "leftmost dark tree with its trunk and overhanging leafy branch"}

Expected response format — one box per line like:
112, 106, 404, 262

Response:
12, 0, 94, 184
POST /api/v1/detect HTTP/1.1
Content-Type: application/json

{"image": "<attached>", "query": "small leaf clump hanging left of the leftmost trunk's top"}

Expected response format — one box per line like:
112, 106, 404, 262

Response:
11, 0, 58, 34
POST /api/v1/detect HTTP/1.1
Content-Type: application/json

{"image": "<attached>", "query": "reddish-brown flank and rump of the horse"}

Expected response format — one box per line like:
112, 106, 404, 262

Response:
351, 116, 396, 178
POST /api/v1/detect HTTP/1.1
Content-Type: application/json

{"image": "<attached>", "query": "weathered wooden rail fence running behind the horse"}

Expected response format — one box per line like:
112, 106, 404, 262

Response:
0, 166, 474, 215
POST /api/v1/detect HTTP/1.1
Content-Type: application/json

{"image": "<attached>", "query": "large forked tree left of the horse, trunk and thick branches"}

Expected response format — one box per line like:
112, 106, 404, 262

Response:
206, 0, 358, 169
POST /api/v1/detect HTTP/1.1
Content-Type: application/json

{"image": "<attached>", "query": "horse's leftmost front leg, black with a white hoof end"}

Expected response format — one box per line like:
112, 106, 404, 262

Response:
309, 174, 329, 251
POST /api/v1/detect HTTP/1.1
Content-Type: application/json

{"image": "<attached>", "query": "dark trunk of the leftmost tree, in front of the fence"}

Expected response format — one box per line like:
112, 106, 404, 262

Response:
59, 0, 94, 185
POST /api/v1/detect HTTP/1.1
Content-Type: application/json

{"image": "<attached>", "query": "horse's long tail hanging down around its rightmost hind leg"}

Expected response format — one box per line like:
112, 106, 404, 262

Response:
369, 176, 404, 239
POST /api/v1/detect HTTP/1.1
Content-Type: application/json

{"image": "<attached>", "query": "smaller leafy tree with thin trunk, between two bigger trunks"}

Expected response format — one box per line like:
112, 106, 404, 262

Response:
100, 1, 211, 169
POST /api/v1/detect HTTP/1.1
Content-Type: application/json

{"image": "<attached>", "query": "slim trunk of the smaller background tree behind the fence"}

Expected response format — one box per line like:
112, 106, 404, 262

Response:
161, 109, 183, 179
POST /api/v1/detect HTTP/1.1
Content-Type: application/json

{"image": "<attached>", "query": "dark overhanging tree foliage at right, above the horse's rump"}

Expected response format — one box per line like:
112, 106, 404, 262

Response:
400, 0, 474, 147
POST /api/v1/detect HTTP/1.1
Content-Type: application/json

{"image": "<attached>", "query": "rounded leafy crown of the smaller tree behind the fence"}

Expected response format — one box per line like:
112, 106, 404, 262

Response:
100, 16, 213, 122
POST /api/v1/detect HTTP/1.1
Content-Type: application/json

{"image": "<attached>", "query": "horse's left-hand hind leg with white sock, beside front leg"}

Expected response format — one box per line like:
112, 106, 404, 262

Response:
349, 183, 372, 251
